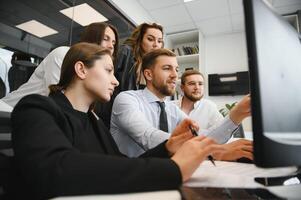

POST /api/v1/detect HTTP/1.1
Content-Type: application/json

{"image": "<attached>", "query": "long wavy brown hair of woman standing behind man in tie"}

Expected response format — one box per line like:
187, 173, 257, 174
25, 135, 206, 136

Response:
124, 23, 163, 68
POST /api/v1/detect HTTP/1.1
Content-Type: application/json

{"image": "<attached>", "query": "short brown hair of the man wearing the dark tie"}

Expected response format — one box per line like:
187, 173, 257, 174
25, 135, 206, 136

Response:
141, 48, 176, 71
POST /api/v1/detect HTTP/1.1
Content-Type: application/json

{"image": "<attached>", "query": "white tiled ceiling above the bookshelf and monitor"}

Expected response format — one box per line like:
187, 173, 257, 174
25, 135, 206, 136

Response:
111, 0, 301, 36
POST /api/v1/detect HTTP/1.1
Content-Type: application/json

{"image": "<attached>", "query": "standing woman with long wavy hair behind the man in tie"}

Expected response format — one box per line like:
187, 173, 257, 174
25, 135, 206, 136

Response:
115, 23, 164, 92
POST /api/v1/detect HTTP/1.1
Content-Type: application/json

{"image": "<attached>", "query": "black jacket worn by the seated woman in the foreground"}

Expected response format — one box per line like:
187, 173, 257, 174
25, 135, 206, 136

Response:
12, 92, 181, 199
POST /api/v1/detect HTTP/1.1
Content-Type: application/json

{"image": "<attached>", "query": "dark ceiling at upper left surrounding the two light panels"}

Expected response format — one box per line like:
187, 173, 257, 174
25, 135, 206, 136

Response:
0, 0, 134, 57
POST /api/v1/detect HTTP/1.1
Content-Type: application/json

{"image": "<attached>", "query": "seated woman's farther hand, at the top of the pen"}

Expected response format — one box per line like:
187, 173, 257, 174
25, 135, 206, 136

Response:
166, 118, 199, 155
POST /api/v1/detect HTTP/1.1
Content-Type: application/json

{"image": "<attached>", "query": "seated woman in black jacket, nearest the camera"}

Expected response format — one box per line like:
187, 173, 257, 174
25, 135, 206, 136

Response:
12, 43, 222, 199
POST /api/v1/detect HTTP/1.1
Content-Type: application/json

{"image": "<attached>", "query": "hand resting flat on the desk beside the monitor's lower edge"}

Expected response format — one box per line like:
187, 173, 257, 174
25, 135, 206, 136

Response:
212, 139, 253, 161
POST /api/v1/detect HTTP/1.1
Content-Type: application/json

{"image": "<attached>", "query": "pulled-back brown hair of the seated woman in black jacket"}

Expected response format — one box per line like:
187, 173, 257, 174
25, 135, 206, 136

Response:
49, 42, 111, 93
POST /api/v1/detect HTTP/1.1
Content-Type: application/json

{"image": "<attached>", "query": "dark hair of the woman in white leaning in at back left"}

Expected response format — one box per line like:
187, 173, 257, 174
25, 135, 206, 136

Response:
80, 22, 118, 58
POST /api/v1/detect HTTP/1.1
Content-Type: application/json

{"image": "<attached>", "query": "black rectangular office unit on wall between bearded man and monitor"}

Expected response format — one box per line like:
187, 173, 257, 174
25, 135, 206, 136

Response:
208, 72, 249, 96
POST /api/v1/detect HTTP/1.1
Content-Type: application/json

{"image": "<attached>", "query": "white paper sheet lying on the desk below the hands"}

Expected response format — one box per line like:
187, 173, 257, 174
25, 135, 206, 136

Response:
184, 161, 297, 188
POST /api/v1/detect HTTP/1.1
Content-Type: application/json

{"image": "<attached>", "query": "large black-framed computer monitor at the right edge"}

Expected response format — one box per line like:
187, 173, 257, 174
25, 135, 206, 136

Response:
244, 0, 301, 167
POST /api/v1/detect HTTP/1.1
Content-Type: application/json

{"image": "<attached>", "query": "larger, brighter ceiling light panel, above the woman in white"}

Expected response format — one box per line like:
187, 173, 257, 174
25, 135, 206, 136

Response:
60, 3, 108, 26
